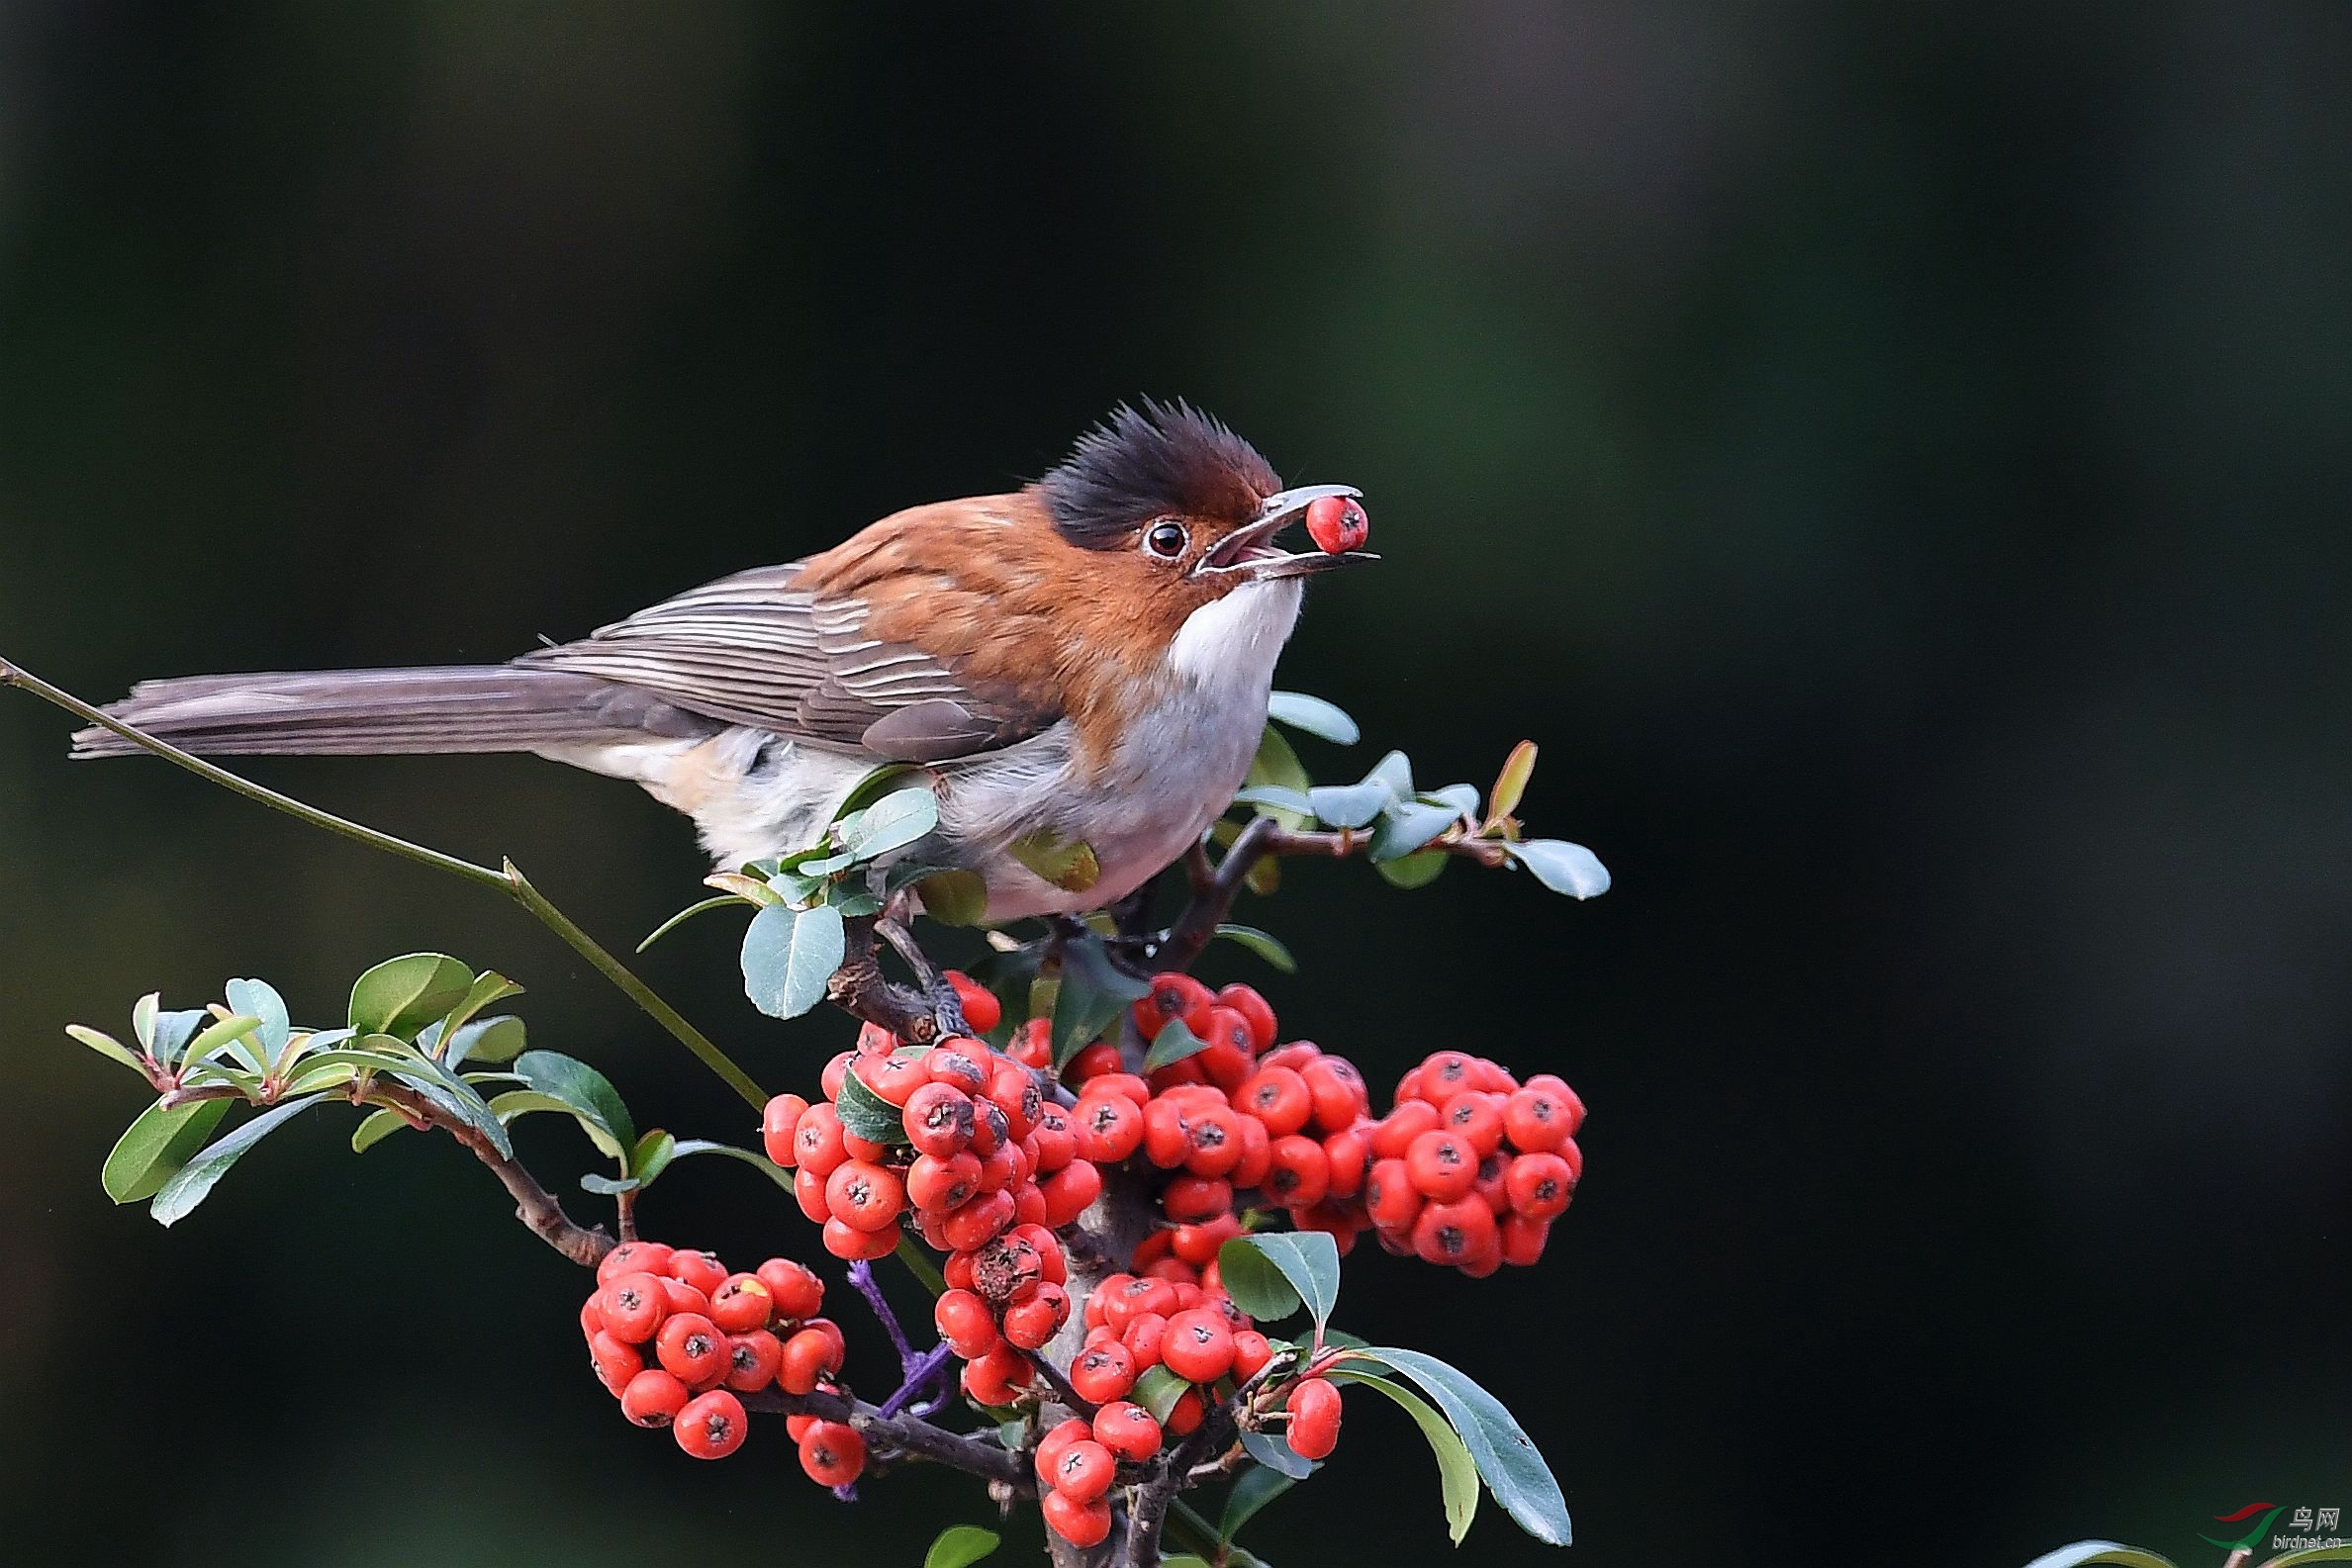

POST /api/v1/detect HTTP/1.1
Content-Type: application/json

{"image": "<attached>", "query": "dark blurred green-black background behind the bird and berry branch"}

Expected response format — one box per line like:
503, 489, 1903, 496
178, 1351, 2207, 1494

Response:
0, 2, 2352, 1568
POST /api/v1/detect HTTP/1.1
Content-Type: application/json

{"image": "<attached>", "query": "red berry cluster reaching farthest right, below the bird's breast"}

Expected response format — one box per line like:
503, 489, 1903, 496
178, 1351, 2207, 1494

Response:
1071, 973, 1585, 1283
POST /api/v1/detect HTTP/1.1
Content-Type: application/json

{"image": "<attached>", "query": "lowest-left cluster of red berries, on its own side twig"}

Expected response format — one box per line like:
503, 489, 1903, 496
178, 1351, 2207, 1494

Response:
581, 1242, 866, 1486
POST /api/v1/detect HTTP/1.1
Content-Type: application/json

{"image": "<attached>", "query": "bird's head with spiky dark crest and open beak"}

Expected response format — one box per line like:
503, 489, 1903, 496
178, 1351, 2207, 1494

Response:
1037, 400, 1376, 663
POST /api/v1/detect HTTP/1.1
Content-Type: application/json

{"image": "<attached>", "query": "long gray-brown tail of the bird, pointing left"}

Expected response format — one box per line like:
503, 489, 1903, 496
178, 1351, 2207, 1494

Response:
73, 665, 722, 757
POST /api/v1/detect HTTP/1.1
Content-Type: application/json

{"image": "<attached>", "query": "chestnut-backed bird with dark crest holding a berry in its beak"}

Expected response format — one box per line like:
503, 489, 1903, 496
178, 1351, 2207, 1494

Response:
75, 402, 1373, 922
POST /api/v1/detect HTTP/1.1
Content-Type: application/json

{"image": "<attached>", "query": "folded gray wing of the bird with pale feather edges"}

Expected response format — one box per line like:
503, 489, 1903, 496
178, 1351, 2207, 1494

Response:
516, 562, 1061, 762
